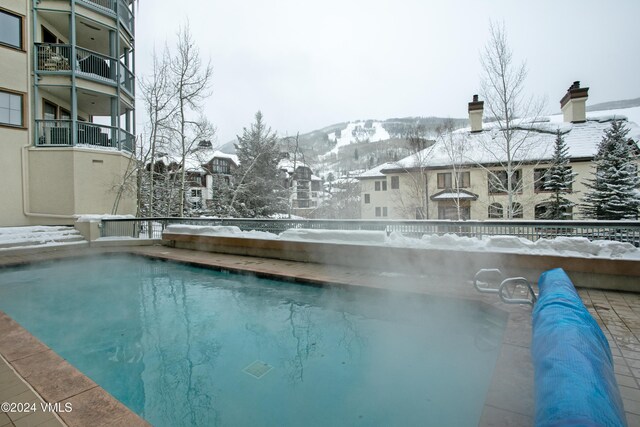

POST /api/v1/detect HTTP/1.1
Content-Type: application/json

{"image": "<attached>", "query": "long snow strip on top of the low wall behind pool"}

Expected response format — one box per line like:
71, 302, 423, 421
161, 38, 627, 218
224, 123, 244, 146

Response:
167, 225, 640, 260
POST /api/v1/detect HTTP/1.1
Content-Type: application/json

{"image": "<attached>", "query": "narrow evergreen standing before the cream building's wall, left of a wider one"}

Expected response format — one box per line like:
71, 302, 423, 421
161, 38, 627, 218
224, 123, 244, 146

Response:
542, 130, 577, 219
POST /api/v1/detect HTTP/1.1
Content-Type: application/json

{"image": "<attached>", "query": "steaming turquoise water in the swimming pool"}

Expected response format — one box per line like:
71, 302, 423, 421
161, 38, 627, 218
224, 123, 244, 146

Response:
0, 255, 506, 427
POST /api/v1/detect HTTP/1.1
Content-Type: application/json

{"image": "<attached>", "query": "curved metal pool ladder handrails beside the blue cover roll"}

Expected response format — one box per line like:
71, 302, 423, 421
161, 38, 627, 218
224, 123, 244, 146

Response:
473, 268, 538, 306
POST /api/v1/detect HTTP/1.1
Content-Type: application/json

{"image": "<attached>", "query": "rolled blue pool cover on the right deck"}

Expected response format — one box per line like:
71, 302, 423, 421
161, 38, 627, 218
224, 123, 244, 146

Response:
531, 268, 627, 427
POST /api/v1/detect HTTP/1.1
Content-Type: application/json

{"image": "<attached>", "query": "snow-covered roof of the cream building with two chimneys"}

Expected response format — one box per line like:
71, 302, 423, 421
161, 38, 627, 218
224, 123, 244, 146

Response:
384, 107, 640, 173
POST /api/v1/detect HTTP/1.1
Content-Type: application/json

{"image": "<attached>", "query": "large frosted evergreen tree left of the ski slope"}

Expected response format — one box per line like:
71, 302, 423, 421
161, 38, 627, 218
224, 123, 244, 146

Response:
230, 111, 286, 217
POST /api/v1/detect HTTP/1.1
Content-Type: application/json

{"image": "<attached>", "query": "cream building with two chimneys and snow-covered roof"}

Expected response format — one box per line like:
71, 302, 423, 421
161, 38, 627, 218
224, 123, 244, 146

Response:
359, 82, 640, 220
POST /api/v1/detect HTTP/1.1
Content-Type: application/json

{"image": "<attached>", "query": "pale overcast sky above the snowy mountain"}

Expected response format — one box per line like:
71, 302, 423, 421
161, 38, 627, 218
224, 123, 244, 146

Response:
136, 0, 640, 144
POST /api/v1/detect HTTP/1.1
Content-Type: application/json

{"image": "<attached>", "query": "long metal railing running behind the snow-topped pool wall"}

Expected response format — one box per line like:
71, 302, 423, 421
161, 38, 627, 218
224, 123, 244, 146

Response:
101, 218, 640, 246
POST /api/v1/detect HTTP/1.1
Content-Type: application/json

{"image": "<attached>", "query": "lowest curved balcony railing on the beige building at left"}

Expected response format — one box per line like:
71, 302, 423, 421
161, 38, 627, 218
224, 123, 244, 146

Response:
35, 120, 135, 153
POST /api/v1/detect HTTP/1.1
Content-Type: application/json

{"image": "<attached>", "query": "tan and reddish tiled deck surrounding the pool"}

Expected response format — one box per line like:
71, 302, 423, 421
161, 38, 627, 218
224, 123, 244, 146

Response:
0, 246, 640, 427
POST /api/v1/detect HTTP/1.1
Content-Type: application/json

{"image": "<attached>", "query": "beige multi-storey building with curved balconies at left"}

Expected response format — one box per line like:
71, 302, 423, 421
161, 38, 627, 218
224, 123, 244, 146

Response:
0, 0, 136, 226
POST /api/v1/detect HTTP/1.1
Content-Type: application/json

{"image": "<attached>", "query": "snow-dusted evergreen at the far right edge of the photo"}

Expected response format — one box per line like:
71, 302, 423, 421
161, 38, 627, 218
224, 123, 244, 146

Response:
581, 120, 640, 220
